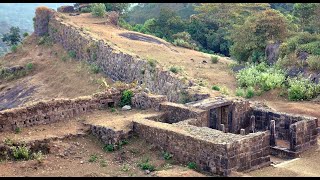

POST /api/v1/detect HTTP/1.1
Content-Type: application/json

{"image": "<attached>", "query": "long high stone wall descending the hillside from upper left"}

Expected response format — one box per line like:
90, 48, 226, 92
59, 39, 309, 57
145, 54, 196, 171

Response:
35, 10, 206, 102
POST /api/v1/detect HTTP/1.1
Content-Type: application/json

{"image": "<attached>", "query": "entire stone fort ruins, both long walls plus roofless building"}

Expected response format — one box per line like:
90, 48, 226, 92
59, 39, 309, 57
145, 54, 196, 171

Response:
0, 6, 318, 176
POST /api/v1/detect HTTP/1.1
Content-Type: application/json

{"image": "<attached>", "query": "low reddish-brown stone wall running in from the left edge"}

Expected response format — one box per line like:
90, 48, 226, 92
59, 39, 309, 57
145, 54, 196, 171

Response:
0, 90, 121, 132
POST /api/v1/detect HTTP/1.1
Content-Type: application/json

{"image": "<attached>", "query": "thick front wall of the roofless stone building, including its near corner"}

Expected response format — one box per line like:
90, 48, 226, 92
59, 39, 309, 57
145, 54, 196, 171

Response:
133, 120, 270, 176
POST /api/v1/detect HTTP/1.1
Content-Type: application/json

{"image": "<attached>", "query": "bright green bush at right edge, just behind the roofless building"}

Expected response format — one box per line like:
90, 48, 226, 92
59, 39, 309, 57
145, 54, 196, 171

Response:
288, 77, 320, 101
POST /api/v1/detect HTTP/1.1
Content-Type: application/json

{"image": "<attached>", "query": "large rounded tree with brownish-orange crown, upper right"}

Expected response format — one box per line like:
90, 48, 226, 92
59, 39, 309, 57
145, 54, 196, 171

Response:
230, 9, 288, 62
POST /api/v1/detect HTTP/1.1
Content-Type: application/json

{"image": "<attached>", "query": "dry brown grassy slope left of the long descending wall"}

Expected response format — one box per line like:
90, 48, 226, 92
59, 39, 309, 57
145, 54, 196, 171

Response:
0, 35, 112, 110
